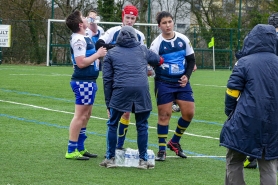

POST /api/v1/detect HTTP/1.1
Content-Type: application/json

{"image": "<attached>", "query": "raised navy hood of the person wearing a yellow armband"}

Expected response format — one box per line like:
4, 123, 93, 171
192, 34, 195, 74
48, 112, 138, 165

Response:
236, 24, 277, 59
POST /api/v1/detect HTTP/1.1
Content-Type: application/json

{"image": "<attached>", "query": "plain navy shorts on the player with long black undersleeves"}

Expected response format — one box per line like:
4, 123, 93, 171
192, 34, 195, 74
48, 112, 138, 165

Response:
155, 81, 194, 105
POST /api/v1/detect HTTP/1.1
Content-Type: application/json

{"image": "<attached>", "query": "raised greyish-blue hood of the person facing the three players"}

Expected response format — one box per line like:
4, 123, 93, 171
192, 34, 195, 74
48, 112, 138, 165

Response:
116, 26, 141, 48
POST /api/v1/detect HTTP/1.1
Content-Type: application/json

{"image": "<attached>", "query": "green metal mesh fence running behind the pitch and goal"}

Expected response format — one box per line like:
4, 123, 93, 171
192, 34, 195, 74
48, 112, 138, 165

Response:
0, 20, 249, 69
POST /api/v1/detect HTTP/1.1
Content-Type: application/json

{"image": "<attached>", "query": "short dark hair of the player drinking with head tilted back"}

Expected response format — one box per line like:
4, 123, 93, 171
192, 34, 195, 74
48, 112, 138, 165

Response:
66, 10, 83, 33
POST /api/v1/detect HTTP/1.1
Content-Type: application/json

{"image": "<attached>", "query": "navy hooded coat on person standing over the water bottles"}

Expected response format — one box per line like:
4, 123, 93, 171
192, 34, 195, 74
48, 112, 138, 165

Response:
103, 28, 160, 113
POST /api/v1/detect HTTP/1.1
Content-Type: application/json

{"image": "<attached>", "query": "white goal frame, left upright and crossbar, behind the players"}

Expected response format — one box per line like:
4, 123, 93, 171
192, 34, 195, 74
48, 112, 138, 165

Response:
46, 19, 157, 66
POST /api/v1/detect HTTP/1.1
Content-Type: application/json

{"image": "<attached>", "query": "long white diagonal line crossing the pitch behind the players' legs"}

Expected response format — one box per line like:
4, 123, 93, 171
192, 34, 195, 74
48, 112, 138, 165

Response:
0, 100, 219, 140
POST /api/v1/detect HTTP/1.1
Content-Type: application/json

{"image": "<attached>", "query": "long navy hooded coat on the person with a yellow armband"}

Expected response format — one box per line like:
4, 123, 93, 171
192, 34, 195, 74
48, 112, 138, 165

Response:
220, 24, 278, 160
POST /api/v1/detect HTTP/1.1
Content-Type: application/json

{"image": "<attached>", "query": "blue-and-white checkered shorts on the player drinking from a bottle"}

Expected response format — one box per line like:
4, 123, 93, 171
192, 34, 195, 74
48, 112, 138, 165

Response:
70, 81, 97, 105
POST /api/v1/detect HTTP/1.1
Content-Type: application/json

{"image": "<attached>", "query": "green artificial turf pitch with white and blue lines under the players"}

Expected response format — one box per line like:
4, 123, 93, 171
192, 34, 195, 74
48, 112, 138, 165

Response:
0, 64, 270, 185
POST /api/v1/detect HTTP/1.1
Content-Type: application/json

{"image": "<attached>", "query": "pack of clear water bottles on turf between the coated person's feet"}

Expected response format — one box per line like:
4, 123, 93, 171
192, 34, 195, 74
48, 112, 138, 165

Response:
115, 148, 155, 167
